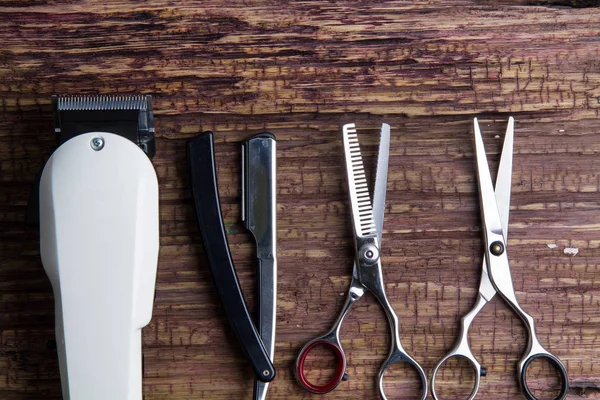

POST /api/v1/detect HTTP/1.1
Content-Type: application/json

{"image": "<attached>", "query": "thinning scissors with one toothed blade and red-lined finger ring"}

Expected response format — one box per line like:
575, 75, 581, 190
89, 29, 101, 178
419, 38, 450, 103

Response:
295, 124, 427, 400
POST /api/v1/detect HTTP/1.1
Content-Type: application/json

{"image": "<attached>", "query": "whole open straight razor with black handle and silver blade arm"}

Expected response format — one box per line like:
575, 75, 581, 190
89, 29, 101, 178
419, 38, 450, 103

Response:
187, 132, 277, 390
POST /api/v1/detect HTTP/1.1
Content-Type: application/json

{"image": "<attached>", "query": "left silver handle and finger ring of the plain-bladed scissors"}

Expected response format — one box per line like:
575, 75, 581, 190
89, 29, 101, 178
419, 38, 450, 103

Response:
431, 293, 487, 400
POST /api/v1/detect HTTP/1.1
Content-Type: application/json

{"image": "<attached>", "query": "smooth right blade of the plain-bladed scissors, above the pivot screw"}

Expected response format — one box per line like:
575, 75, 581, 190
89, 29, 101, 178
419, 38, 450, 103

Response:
496, 117, 515, 241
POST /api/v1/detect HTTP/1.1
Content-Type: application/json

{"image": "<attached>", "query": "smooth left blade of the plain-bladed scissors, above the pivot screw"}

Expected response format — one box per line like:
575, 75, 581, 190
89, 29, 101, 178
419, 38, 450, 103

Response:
473, 118, 503, 235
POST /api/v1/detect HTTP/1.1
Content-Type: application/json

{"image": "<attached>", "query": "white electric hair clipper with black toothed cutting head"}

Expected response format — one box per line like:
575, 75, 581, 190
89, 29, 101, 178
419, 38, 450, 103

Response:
39, 96, 159, 400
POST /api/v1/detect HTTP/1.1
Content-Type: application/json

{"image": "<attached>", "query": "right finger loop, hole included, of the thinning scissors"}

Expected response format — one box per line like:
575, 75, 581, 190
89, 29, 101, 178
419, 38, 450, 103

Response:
383, 362, 423, 400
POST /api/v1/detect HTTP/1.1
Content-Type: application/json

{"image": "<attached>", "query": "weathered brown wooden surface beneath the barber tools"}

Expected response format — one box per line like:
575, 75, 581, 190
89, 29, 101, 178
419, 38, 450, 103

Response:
0, 0, 600, 400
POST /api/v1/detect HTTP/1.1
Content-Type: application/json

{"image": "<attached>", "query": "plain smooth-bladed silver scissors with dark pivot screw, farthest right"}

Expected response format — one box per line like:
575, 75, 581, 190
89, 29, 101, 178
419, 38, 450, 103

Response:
431, 117, 569, 400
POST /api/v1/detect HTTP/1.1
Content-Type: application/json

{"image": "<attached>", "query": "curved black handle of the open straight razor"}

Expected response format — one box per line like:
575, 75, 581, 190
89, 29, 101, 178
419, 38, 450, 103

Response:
187, 132, 275, 382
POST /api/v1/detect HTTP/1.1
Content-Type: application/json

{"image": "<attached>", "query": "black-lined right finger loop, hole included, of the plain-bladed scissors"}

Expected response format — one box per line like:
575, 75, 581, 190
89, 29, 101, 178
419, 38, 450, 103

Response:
523, 355, 566, 400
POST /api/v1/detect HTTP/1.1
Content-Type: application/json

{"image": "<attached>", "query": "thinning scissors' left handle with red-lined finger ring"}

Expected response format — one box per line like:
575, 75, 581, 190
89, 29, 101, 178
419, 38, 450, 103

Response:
295, 272, 365, 394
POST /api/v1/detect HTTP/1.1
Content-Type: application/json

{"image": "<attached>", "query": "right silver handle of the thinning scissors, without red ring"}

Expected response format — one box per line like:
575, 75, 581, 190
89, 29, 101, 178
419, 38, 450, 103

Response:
369, 285, 427, 400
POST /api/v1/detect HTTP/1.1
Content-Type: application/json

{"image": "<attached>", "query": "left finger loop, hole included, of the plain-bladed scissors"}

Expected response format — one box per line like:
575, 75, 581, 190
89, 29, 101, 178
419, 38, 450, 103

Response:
435, 356, 477, 399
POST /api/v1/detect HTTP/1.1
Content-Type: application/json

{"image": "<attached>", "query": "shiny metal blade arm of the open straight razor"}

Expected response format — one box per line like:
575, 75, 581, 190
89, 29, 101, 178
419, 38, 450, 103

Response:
242, 133, 277, 400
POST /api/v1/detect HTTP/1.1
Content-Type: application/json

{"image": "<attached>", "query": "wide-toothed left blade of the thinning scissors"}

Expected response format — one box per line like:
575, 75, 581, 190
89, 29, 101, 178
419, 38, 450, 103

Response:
342, 124, 376, 237
